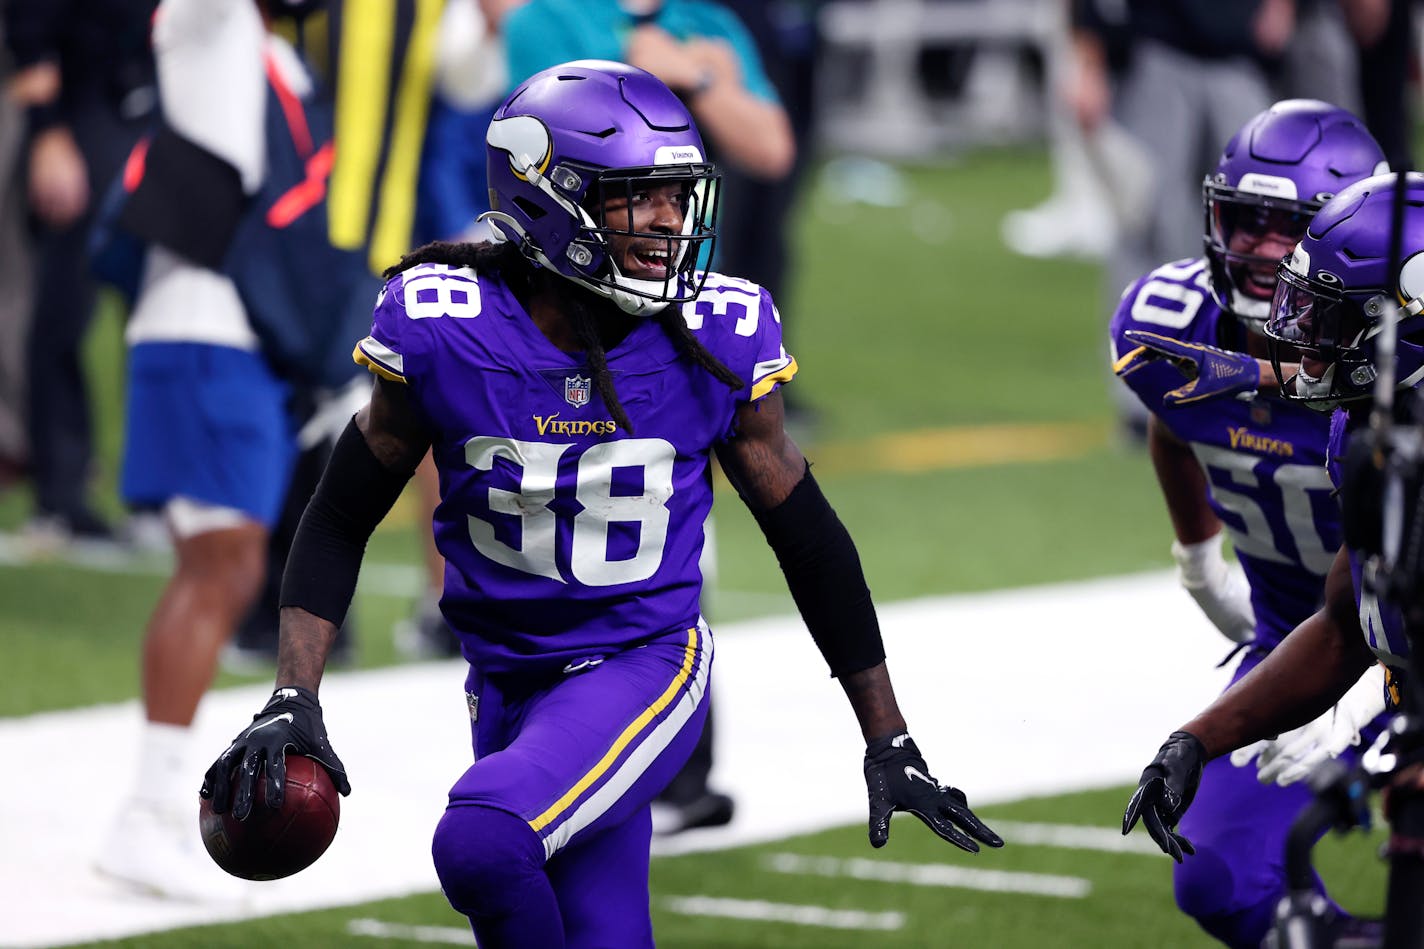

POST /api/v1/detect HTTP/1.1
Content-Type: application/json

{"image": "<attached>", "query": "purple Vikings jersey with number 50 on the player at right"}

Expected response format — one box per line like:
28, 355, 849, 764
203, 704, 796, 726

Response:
1111, 259, 1340, 647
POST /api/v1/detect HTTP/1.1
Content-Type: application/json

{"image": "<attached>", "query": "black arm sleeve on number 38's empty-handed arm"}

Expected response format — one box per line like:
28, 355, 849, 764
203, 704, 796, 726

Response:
753, 465, 886, 677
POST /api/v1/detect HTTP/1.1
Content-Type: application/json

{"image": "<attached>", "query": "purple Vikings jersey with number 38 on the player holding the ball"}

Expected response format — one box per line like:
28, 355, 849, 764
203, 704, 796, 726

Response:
356, 265, 796, 674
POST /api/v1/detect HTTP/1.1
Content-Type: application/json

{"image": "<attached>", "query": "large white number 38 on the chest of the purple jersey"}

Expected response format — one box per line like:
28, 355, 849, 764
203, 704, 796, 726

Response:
464, 436, 676, 587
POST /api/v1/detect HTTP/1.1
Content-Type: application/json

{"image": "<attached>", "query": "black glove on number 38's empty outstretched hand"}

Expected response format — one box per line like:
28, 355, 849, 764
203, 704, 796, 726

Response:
866, 734, 1004, 854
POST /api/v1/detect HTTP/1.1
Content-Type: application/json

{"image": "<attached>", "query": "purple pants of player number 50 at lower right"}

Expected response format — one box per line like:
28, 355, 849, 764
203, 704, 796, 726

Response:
1172, 650, 1378, 949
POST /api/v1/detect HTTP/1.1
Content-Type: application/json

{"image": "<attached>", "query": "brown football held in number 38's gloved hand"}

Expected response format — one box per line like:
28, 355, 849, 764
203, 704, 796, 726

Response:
198, 754, 342, 879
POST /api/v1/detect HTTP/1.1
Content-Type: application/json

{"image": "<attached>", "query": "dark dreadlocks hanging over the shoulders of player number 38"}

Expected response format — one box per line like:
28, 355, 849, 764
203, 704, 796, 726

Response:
384, 241, 746, 433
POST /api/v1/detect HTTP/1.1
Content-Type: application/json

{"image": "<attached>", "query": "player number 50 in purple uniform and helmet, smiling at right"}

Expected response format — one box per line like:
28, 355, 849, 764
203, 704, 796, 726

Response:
1111, 100, 1384, 946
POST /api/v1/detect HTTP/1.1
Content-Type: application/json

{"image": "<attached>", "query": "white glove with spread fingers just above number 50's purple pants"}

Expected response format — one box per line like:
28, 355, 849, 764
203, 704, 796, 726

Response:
1232, 664, 1384, 787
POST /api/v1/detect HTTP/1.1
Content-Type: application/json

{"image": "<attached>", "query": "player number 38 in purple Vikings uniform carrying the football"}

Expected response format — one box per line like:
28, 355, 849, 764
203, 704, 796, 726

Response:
202, 61, 1002, 949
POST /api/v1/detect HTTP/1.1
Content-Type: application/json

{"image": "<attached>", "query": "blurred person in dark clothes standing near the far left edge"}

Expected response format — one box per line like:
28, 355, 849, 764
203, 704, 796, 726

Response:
3, 0, 157, 540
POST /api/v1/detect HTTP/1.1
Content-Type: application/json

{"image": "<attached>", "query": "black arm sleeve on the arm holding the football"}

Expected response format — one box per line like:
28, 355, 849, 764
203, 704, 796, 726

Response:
279, 420, 414, 626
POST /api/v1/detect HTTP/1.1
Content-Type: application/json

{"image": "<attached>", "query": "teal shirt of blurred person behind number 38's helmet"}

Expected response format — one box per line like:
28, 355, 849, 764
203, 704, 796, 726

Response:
503, 0, 779, 103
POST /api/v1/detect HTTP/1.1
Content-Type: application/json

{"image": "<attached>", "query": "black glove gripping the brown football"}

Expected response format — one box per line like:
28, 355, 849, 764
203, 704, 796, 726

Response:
198, 685, 352, 821
